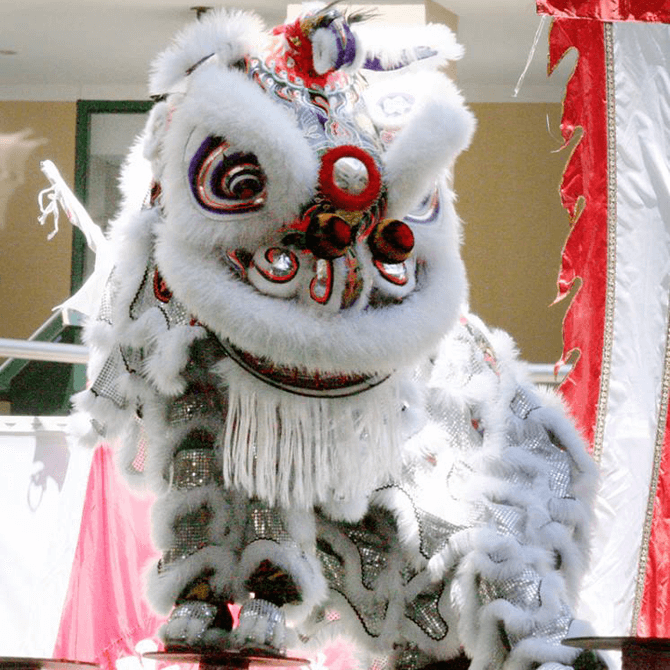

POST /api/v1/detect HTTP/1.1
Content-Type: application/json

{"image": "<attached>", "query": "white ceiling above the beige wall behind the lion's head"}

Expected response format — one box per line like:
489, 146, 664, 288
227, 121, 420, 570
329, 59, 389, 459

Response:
0, 0, 570, 102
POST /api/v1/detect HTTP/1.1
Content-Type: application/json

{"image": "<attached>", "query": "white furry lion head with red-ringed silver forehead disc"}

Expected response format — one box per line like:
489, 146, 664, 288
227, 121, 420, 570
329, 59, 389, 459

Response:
136, 7, 474, 388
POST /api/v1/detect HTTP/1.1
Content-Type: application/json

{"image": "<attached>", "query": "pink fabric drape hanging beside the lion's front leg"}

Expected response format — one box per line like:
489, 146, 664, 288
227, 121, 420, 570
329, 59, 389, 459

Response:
54, 445, 161, 670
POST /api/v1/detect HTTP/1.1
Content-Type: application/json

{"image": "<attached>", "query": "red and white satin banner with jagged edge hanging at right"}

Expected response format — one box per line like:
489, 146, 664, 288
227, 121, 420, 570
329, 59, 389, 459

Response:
538, 0, 670, 637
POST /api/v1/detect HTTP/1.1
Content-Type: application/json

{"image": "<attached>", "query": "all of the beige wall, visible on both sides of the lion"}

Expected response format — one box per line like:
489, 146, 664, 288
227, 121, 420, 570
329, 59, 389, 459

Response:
0, 102, 568, 363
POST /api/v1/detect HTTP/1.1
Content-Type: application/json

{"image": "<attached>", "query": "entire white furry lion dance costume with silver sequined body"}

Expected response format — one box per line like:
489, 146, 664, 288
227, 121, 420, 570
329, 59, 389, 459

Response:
75, 6, 595, 670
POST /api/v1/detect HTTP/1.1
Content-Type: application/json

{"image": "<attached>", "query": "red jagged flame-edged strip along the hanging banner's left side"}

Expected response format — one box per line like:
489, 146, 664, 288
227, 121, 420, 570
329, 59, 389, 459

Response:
549, 19, 608, 452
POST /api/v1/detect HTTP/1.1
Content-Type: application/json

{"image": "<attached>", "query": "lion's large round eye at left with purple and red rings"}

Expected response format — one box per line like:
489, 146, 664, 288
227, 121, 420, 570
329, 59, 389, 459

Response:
188, 137, 267, 214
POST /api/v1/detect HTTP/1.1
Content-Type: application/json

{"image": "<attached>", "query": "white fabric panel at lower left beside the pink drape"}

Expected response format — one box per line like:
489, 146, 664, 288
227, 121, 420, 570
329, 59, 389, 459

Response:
0, 416, 93, 657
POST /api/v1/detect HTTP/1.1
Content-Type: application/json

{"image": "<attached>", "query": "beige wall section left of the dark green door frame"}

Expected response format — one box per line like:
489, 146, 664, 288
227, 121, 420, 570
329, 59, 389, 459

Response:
0, 102, 76, 338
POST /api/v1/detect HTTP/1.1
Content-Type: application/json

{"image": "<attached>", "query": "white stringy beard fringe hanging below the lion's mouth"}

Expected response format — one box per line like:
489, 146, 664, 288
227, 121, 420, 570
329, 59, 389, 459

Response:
216, 360, 400, 517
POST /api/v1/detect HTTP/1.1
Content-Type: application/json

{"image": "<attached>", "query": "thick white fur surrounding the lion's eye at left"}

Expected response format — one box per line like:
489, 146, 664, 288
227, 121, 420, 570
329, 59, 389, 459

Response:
159, 63, 318, 252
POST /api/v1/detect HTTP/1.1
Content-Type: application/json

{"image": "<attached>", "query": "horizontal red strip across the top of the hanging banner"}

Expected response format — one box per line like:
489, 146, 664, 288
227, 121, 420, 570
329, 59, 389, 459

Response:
537, 0, 670, 23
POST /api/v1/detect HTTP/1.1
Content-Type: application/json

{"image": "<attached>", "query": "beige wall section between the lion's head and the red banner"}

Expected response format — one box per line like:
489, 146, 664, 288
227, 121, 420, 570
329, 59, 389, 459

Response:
455, 103, 569, 363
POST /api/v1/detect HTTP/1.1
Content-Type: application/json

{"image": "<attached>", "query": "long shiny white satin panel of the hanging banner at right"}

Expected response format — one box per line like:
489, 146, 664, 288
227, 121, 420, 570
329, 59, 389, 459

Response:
580, 23, 670, 635
